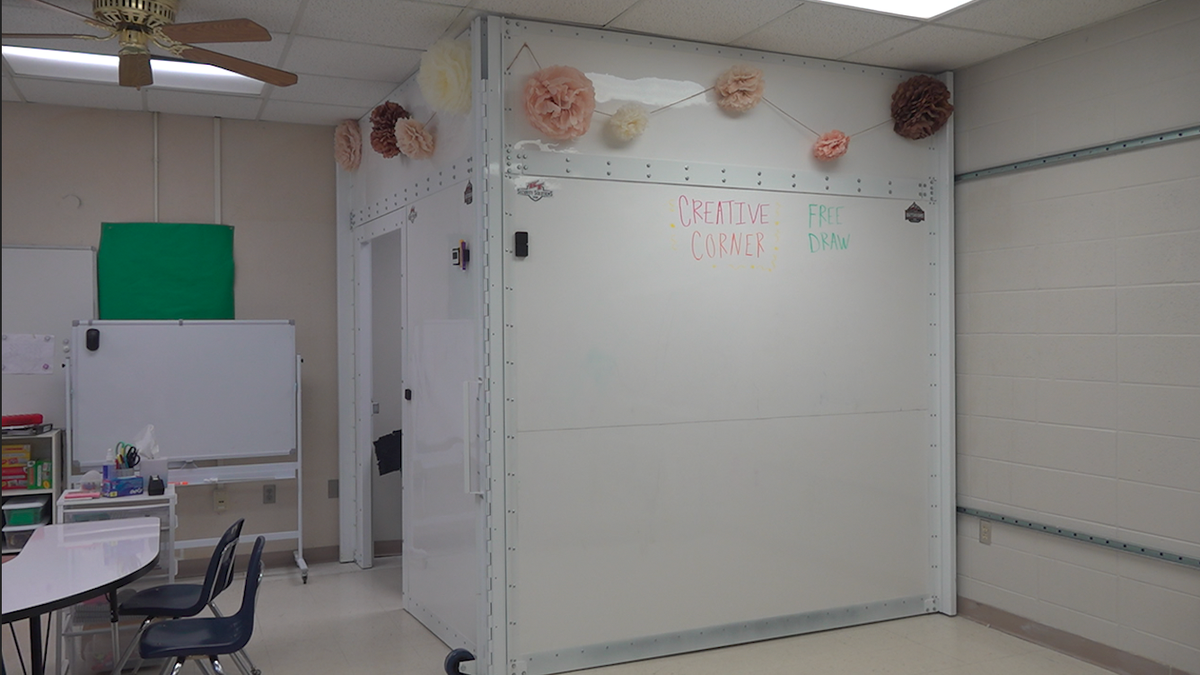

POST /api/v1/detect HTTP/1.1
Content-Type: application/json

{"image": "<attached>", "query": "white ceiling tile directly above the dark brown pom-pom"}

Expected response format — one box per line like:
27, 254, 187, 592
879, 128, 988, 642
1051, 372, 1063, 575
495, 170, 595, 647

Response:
846, 25, 1033, 72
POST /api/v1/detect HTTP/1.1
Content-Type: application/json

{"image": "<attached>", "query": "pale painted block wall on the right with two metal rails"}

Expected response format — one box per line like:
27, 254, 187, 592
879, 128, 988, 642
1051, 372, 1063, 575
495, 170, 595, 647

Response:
955, 0, 1200, 674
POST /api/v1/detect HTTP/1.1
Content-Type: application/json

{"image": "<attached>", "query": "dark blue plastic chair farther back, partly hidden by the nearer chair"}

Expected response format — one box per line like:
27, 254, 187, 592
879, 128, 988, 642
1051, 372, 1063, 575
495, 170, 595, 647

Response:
113, 518, 246, 675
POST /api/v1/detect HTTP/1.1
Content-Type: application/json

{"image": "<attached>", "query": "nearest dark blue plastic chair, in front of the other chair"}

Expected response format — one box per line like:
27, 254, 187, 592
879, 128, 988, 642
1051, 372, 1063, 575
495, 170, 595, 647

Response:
139, 536, 266, 675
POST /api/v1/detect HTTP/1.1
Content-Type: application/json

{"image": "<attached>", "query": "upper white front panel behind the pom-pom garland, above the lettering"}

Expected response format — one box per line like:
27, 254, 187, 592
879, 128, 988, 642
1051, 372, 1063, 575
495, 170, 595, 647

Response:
503, 19, 948, 186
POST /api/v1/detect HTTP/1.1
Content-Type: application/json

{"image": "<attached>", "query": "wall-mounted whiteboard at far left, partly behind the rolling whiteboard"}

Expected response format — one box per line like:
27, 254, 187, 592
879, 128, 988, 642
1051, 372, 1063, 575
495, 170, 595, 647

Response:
0, 246, 96, 429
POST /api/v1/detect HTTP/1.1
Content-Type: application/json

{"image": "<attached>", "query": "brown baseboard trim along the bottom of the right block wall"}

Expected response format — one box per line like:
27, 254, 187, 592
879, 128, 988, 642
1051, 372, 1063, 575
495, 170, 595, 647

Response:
959, 596, 1190, 675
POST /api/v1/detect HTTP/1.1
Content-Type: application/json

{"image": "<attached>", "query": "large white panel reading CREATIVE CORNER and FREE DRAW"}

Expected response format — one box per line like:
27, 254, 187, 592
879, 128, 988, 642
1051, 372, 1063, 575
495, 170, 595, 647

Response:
505, 179, 935, 653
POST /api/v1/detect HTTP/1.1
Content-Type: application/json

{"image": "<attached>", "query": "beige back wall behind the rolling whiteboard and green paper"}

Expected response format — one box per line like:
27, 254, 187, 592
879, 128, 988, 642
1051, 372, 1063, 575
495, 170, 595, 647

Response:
2, 101, 337, 555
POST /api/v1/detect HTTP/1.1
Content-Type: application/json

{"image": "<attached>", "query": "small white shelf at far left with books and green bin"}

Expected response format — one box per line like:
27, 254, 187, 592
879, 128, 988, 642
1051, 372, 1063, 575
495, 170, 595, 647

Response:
0, 429, 62, 555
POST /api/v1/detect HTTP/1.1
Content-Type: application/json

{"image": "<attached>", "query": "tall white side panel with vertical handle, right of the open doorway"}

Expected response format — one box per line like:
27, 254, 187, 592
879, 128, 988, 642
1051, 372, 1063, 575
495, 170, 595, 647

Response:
402, 187, 484, 652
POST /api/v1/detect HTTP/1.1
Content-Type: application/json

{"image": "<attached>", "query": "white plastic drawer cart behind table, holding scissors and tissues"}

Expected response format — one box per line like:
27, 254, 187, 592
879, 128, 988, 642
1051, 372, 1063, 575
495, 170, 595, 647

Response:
56, 484, 178, 675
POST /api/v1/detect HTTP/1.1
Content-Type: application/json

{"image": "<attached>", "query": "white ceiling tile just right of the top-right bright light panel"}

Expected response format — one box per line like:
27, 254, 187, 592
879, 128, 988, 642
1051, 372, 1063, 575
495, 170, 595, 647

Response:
935, 0, 1154, 40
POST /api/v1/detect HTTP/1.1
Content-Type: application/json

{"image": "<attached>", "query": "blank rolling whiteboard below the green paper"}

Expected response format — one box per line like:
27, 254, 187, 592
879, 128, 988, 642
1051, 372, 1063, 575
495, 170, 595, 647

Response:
70, 321, 296, 466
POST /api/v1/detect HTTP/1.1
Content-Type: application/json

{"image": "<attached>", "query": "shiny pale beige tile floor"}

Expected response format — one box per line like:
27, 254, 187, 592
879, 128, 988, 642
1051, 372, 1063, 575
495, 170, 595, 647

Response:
4, 557, 1109, 675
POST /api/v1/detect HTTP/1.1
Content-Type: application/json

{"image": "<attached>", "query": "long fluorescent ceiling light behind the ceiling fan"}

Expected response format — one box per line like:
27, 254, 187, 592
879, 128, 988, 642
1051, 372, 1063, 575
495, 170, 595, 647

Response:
4, 44, 263, 96
